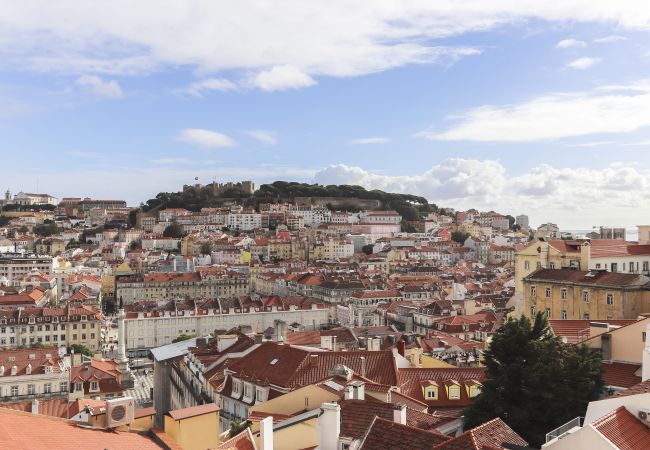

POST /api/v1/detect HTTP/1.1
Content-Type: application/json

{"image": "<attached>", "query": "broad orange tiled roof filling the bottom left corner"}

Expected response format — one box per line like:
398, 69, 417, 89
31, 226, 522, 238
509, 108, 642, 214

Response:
0, 408, 160, 450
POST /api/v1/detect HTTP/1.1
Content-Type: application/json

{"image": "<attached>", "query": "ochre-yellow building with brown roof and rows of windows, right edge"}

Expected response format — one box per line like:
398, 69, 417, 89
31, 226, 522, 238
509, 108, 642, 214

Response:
522, 269, 650, 320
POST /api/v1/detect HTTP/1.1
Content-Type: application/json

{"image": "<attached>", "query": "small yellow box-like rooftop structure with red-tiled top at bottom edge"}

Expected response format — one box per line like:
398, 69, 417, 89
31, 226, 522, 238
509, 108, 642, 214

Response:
165, 403, 219, 450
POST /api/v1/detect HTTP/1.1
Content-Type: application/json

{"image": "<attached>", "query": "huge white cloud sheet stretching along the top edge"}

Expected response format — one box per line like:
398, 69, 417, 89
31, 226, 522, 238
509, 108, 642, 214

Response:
0, 0, 650, 81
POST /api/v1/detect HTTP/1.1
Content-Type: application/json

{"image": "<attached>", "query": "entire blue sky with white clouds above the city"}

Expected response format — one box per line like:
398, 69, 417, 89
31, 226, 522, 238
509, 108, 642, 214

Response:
0, 0, 650, 229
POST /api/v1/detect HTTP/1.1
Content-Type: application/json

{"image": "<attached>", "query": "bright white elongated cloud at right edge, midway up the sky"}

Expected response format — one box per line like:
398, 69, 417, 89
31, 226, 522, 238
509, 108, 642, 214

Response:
416, 78, 650, 142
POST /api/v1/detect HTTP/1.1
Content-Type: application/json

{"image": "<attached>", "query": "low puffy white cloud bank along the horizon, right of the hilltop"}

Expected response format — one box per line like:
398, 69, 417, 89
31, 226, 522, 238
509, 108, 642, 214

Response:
314, 159, 650, 229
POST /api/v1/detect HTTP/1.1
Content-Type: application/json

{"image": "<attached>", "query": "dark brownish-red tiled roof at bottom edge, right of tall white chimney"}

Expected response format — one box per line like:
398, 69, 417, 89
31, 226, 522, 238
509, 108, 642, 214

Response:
360, 417, 449, 450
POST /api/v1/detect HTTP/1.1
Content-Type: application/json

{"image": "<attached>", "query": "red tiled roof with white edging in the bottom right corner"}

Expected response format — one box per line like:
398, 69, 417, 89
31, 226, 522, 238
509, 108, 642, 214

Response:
592, 406, 650, 450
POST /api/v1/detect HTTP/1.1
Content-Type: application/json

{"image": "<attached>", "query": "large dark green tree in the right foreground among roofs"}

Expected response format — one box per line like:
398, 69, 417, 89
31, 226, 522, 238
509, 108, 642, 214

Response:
465, 313, 603, 446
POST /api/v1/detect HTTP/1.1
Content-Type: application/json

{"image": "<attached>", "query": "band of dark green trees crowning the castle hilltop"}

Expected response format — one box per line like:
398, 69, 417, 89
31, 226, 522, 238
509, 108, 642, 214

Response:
141, 181, 438, 220
